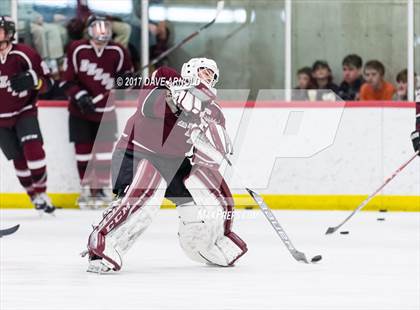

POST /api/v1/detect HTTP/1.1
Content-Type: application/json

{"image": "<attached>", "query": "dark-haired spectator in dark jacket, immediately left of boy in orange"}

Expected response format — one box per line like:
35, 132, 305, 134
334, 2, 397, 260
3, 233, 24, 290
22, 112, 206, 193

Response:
338, 54, 365, 100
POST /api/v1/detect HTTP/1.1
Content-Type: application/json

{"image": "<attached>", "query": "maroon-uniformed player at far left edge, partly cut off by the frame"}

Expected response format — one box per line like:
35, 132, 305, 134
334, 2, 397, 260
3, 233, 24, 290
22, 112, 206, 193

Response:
0, 16, 55, 213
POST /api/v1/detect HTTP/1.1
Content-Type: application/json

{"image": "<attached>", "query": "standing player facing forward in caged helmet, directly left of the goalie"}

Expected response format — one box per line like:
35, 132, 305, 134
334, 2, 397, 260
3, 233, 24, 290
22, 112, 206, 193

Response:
61, 15, 132, 208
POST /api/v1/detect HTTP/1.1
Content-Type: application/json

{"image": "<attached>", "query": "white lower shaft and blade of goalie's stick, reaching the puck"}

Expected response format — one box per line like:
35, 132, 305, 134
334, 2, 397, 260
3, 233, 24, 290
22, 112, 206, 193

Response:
245, 188, 322, 264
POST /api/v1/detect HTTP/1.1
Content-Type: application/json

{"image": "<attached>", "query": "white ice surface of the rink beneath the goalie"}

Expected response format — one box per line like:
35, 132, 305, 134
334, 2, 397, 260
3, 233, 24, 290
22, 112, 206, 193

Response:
0, 210, 420, 310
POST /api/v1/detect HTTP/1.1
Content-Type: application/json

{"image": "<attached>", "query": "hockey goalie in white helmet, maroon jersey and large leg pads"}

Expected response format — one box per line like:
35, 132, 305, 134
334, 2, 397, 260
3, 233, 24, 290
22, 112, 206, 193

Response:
85, 58, 247, 273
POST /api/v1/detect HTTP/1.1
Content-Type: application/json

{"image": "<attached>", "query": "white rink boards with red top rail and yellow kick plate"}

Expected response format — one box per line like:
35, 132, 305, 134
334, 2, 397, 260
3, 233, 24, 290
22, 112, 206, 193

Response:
0, 101, 420, 211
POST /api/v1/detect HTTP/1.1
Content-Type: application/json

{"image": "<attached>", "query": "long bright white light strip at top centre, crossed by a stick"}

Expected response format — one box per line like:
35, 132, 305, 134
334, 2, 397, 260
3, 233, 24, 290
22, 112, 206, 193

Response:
149, 6, 246, 24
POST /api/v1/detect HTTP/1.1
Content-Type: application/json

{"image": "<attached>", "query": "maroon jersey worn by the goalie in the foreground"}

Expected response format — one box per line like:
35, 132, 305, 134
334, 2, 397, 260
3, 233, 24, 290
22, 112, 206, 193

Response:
117, 67, 225, 157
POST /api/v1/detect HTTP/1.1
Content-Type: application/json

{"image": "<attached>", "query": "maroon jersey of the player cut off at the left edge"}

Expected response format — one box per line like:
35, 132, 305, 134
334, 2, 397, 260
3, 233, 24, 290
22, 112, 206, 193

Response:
0, 44, 50, 127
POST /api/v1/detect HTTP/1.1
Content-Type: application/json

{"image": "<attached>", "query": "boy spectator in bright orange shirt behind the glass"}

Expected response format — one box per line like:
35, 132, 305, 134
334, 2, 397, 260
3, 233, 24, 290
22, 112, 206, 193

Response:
360, 60, 395, 100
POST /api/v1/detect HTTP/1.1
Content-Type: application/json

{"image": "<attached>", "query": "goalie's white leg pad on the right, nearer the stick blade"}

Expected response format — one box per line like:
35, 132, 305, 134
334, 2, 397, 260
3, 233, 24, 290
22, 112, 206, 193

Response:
178, 174, 246, 266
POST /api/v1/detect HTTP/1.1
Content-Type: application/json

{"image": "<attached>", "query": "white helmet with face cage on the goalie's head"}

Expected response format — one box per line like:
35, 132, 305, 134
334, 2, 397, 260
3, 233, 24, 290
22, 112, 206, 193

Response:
181, 58, 219, 88
